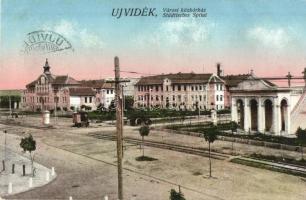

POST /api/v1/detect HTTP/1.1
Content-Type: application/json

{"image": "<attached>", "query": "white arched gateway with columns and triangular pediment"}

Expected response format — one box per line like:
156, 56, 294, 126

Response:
229, 75, 303, 135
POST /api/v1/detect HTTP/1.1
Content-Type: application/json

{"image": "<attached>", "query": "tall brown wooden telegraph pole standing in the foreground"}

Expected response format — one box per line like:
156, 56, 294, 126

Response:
115, 56, 123, 200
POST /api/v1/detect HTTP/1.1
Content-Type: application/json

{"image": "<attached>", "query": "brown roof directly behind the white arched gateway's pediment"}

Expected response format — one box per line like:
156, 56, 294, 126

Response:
221, 74, 276, 87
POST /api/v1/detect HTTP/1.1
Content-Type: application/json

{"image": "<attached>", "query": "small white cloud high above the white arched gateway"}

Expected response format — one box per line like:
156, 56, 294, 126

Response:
247, 26, 291, 49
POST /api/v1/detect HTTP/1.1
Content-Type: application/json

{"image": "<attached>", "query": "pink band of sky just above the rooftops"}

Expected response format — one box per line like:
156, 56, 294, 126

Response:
0, 53, 303, 89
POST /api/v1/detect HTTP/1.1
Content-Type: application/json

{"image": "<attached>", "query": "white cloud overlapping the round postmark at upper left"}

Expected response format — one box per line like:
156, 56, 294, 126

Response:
43, 20, 104, 49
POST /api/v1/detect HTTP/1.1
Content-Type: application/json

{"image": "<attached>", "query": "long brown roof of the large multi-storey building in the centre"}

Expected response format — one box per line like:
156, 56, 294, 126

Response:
136, 73, 213, 85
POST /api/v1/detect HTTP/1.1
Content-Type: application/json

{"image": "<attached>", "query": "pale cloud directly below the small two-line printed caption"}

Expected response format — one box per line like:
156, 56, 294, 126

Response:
137, 18, 216, 46
